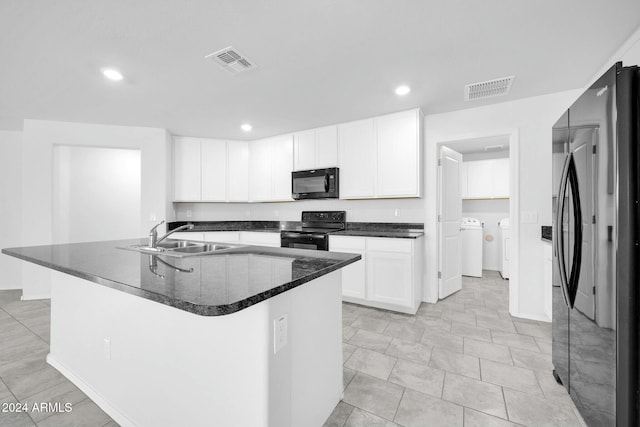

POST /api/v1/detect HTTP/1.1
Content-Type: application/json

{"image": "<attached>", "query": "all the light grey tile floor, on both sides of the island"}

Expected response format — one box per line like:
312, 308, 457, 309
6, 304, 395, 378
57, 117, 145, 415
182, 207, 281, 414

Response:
0, 271, 581, 427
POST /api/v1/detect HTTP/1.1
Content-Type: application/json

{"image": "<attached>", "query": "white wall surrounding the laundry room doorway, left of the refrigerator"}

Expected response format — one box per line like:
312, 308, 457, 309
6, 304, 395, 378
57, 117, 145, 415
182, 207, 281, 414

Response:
424, 90, 581, 318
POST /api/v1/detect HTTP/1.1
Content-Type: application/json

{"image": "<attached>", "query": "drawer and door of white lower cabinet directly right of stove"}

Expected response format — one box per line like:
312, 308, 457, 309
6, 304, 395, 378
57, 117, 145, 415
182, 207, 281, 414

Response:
329, 236, 366, 299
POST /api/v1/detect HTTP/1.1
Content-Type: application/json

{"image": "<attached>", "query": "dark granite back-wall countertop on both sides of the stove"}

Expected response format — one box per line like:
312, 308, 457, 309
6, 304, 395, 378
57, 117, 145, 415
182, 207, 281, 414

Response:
167, 221, 424, 239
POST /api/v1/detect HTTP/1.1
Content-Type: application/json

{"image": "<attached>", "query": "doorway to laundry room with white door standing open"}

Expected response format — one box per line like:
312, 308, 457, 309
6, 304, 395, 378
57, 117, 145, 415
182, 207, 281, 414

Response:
437, 132, 518, 313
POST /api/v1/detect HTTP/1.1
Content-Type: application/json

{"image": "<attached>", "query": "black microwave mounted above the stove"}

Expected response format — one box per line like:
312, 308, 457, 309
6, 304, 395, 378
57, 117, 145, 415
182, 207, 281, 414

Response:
291, 168, 340, 200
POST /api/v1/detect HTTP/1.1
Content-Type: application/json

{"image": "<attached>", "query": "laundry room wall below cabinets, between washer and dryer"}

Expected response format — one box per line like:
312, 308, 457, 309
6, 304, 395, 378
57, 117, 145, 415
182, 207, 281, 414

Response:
462, 199, 509, 271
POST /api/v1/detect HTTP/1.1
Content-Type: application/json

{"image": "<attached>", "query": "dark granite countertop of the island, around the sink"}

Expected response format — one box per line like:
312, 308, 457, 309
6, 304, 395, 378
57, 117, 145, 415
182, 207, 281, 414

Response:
2, 239, 361, 316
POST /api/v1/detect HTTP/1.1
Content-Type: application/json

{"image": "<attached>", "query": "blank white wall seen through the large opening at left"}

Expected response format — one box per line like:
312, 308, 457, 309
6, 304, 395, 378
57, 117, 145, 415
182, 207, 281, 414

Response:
53, 145, 141, 243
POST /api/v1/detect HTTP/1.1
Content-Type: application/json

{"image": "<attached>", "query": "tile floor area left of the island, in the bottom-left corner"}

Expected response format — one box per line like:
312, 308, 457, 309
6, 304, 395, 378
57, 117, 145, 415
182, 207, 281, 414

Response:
0, 291, 118, 427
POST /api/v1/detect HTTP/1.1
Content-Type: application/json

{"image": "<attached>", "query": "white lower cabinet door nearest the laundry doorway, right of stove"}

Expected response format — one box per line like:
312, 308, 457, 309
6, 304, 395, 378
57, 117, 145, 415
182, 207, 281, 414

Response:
367, 251, 413, 307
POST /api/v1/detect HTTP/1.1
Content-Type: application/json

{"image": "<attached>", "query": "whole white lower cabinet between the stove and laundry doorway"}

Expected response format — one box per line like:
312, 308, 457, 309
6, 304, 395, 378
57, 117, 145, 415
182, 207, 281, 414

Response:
329, 236, 423, 314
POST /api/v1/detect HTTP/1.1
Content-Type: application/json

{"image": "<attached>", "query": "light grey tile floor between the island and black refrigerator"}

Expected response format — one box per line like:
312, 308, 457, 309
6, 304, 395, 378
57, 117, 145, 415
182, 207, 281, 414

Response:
325, 271, 583, 427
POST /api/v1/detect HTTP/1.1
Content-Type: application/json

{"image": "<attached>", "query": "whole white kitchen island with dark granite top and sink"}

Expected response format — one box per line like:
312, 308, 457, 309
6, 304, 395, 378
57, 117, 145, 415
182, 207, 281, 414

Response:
2, 240, 360, 426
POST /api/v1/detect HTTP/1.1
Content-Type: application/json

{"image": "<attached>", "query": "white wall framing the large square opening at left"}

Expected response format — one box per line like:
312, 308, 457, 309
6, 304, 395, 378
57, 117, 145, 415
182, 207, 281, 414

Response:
21, 120, 173, 299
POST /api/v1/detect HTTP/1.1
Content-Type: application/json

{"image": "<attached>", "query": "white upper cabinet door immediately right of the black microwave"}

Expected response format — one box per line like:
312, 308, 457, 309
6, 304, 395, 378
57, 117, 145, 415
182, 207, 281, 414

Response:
338, 119, 377, 199
